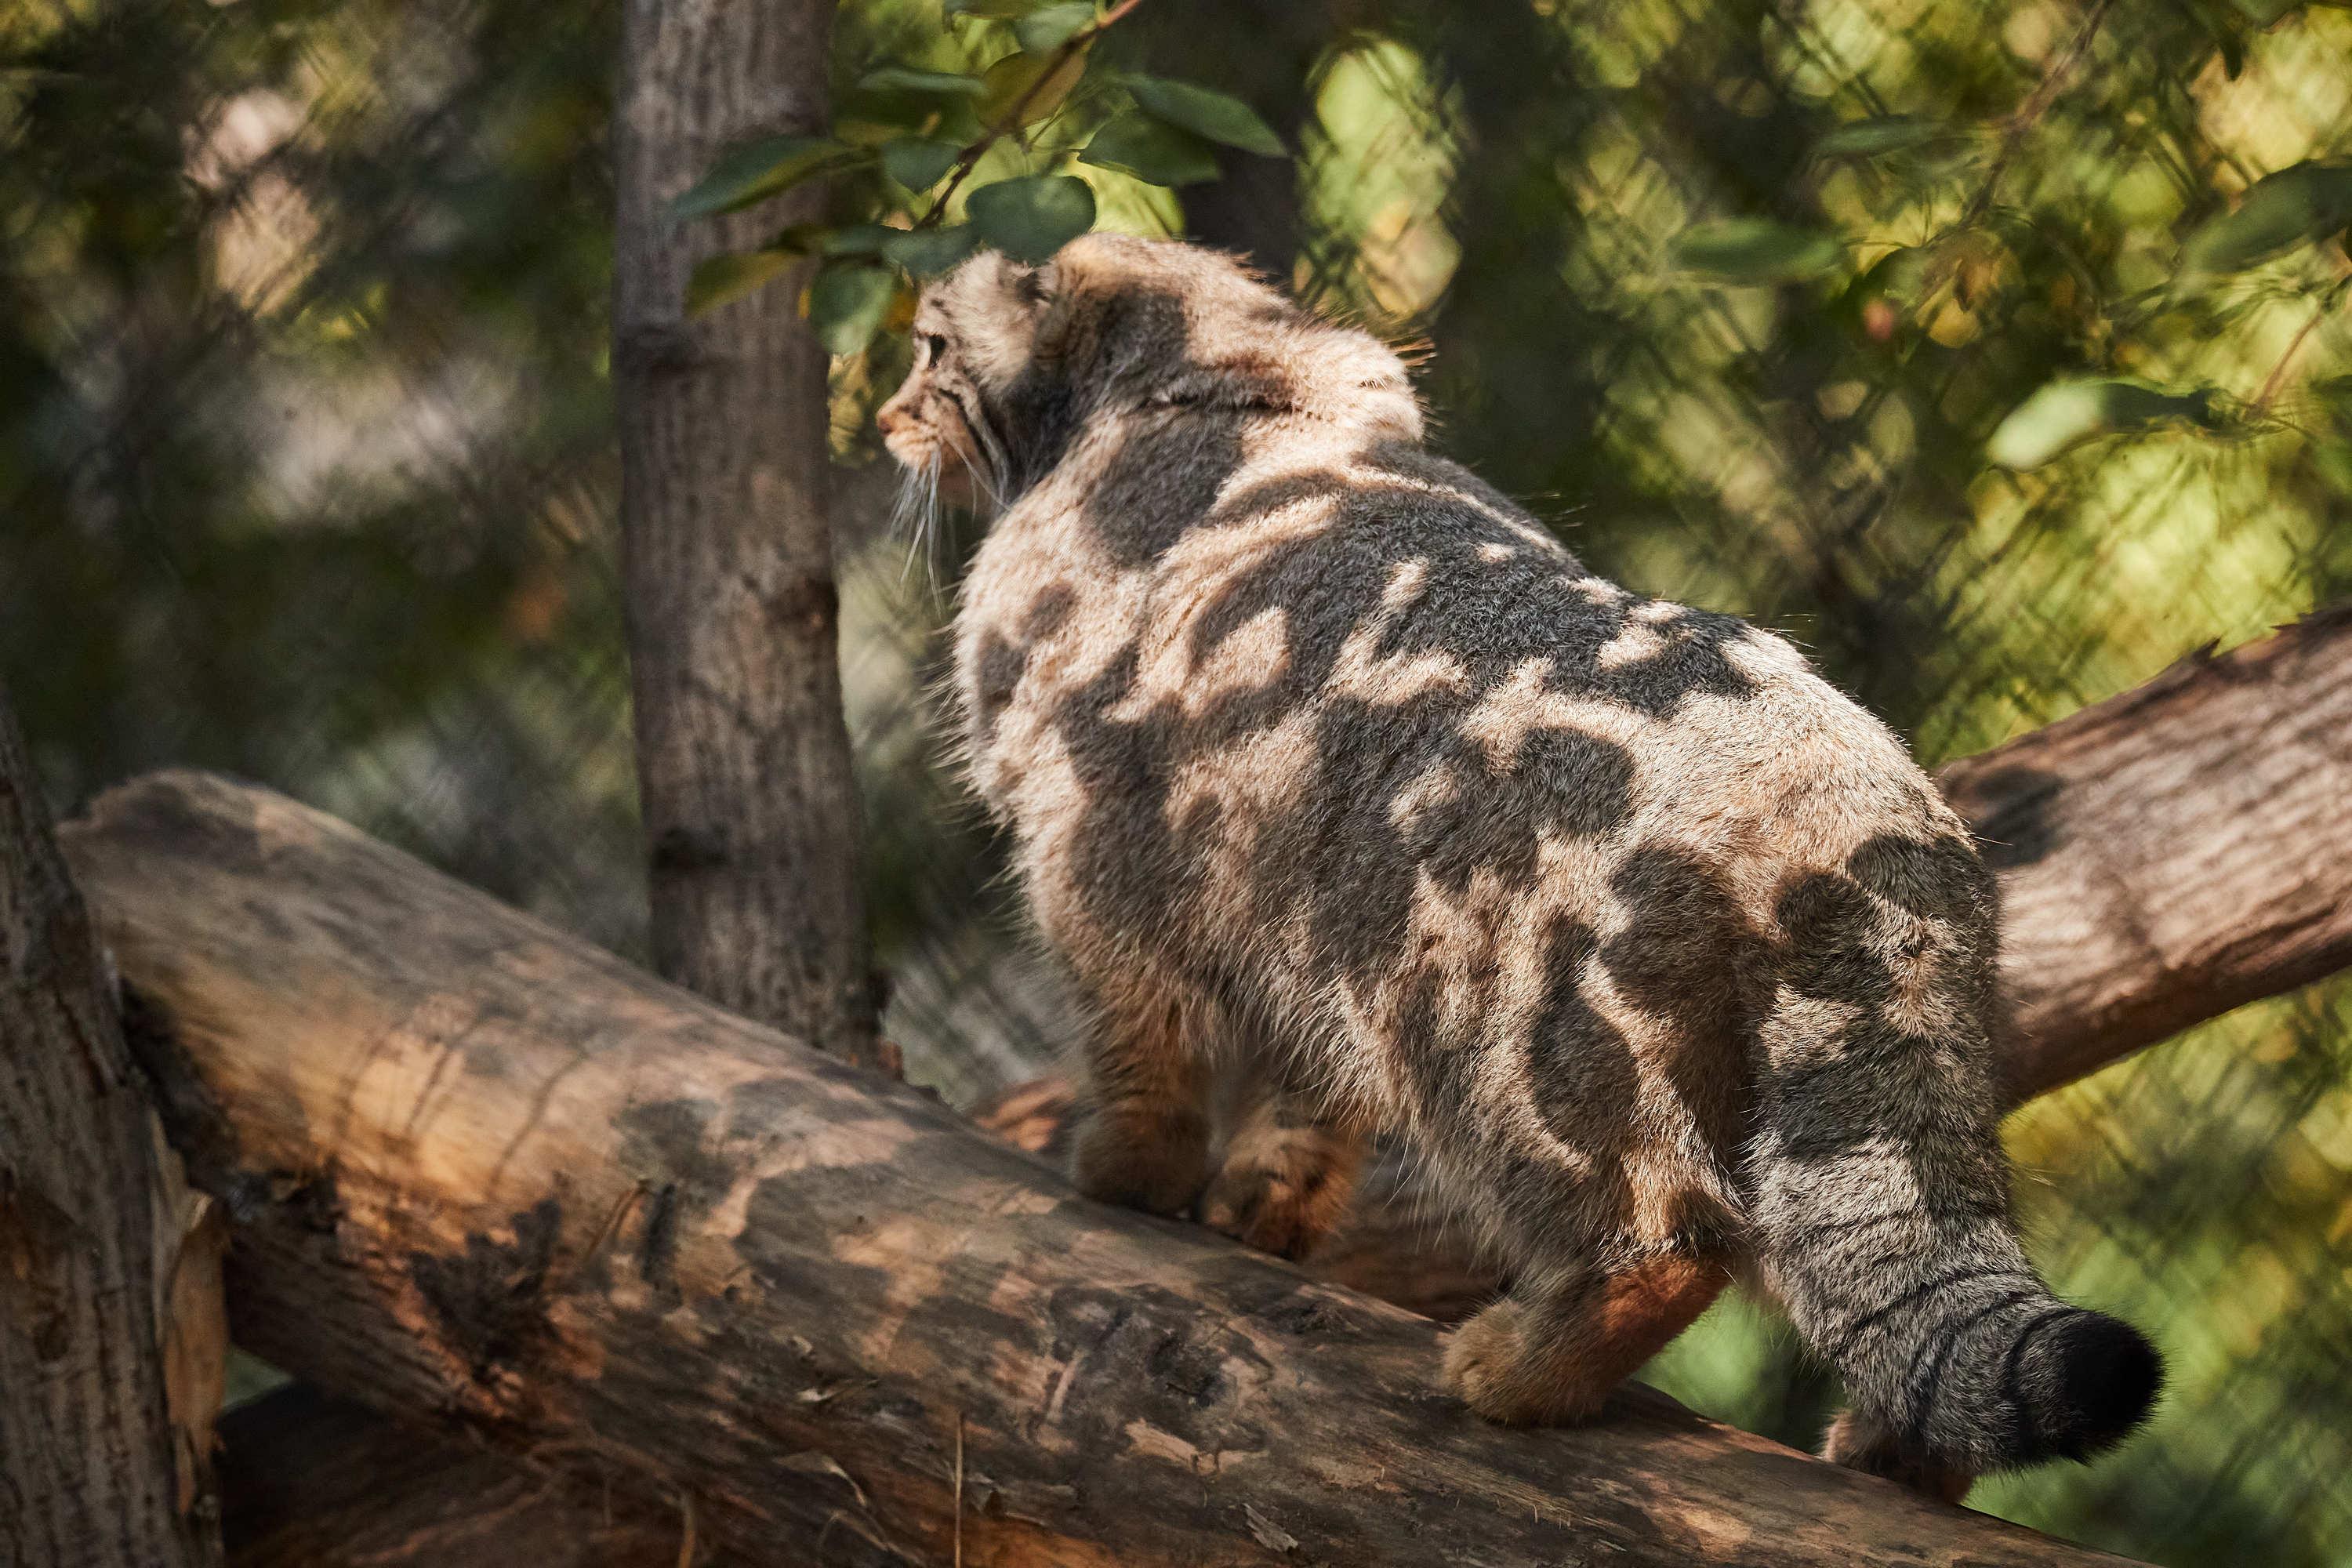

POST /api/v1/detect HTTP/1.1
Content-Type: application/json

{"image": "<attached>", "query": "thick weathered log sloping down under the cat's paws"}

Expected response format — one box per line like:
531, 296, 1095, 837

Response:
68, 774, 2154, 1568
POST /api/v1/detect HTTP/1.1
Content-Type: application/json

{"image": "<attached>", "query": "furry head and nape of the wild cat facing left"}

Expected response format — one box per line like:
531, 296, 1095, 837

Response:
880, 235, 1421, 501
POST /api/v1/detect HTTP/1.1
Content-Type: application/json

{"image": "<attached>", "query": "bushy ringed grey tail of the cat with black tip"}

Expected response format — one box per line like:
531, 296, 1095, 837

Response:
1750, 869, 2164, 1474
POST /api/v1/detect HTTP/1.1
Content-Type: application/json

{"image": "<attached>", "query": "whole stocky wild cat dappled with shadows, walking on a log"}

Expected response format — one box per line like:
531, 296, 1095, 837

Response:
882, 235, 2157, 1493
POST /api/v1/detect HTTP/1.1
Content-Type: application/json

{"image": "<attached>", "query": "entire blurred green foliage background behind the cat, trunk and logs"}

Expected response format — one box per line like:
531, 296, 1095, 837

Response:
0, 0, 2352, 1563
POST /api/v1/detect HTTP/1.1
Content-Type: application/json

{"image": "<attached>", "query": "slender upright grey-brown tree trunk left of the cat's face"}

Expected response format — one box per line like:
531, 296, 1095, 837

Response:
614, 0, 877, 1062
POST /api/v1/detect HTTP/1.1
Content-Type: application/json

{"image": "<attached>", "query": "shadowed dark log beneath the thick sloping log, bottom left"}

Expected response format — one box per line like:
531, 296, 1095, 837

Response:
221, 1385, 743, 1568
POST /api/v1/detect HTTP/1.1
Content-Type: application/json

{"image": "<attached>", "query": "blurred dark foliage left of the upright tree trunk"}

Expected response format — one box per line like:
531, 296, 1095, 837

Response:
0, 0, 642, 940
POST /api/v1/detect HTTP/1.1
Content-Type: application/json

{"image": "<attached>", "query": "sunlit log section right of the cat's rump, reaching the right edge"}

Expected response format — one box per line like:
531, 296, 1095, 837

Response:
1938, 607, 2352, 1102
